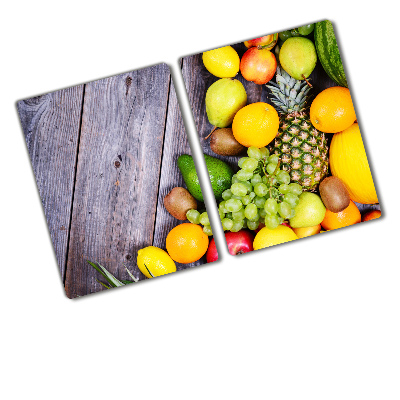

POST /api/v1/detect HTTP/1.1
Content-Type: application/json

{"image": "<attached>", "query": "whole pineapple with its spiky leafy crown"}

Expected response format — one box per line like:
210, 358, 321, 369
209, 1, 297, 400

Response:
266, 65, 328, 192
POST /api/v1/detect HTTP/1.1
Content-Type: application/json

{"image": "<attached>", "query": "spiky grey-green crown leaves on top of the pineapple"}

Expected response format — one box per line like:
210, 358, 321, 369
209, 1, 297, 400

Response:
265, 65, 311, 114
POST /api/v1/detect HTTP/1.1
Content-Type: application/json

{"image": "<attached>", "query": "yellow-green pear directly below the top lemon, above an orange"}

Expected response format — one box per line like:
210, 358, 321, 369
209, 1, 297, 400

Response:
206, 78, 247, 128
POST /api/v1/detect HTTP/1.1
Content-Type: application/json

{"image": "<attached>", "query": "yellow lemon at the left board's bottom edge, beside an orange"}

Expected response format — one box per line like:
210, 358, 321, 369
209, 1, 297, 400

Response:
137, 246, 176, 278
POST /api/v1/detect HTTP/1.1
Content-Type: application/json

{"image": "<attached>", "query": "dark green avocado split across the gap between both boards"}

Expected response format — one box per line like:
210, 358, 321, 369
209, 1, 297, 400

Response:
178, 154, 233, 201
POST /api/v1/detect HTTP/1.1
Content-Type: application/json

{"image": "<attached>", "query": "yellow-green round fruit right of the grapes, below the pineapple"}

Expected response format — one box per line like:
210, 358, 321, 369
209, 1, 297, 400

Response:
289, 192, 326, 228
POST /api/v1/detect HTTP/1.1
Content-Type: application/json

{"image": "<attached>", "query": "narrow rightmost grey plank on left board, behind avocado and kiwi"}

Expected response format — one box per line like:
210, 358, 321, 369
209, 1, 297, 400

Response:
153, 77, 205, 270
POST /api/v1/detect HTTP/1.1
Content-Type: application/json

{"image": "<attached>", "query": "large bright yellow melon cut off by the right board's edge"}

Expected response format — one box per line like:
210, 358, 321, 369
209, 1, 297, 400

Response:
329, 123, 378, 204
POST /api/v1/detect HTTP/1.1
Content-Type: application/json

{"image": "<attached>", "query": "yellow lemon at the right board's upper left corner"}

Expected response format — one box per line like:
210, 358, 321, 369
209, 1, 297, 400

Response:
203, 46, 240, 78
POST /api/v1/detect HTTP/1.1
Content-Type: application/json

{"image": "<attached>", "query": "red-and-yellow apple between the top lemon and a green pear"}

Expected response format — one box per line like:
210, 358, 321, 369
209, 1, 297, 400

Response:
239, 47, 277, 85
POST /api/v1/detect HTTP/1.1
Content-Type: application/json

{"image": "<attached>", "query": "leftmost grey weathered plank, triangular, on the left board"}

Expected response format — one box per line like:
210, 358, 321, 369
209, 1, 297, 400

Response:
17, 85, 83, 279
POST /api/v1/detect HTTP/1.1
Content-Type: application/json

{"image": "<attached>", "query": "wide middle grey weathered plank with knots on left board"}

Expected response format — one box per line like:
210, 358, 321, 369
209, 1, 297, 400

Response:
65, 64, 170, 297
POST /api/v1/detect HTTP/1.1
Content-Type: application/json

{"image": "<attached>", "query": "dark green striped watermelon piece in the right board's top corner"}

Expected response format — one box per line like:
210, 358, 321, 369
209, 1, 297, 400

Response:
314, 20, 348, 87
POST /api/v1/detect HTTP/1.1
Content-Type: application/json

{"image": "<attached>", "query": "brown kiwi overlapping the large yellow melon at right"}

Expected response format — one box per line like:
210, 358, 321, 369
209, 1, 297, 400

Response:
319, 176, 350, 213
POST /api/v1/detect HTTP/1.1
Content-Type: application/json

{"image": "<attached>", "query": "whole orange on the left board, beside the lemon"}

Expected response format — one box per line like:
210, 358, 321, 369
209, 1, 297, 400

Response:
166, 223, 208, 264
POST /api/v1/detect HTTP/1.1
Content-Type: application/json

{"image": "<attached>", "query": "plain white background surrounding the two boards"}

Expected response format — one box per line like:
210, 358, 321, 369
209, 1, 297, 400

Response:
0, 0, 400, 400
